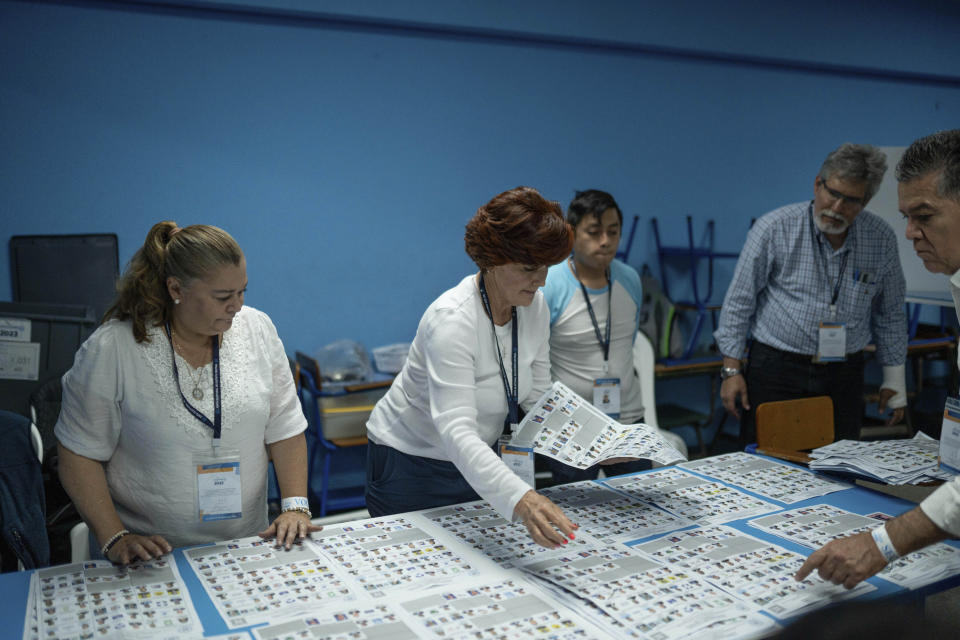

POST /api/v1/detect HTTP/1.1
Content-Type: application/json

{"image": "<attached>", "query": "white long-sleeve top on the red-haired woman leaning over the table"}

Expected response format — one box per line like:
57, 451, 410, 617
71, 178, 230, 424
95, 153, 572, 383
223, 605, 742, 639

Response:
367, 275, 550, 519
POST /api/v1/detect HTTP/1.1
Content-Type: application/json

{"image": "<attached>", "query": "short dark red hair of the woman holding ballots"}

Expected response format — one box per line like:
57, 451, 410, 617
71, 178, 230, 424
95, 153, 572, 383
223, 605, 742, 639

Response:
463, 187, 573, 270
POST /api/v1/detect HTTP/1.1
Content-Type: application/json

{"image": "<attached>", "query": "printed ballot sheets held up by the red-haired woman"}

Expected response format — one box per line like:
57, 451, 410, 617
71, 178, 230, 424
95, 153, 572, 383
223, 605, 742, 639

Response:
513, 382, 686, 469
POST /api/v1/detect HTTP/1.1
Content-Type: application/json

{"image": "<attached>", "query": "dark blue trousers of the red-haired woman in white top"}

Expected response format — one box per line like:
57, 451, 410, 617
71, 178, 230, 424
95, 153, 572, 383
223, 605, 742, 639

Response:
366, 440, 480, 517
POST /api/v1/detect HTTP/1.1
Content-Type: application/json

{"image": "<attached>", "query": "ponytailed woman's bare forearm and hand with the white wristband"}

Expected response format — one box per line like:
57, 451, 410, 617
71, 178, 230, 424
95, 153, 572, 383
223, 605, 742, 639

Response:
260, 433, 323, 549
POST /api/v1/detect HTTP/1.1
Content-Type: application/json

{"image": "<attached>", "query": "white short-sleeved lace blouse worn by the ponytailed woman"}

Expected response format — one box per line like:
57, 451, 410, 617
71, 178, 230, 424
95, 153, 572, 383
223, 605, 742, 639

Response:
55, 307, 306, 546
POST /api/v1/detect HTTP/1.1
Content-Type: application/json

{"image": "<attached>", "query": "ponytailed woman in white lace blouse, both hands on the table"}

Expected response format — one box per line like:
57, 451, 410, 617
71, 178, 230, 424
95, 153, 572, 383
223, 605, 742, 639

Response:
55, 222, 319, 564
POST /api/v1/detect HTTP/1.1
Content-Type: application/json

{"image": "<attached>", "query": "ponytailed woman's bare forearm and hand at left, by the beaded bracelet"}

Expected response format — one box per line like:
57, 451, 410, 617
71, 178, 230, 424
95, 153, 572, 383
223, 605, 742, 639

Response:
57, 443, 173, 564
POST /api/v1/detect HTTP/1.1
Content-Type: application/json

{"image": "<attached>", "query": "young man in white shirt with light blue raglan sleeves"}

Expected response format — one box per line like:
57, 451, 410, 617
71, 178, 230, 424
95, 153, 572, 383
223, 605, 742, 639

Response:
543, 189, 650, 483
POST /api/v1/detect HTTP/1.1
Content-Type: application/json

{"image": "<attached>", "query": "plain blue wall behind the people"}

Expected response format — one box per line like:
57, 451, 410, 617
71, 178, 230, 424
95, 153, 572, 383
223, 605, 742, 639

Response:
0, 0, 960, 352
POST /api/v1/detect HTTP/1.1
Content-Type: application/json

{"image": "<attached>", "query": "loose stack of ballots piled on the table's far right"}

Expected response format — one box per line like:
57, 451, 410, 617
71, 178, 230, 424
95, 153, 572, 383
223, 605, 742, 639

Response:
810, 431, 954, 484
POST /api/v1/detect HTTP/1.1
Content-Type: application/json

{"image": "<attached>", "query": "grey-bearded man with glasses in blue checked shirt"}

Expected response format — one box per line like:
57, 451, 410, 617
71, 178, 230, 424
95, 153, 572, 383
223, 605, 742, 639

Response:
714, 143, 907, 444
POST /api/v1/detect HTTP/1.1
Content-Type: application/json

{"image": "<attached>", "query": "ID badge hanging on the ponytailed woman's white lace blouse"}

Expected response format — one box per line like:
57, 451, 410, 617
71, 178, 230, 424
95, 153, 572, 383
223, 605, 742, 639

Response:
193, 447, 243, 522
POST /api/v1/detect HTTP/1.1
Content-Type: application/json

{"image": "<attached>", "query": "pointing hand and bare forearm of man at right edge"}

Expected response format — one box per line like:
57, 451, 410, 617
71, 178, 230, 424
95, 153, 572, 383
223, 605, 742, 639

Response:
795, 507, 950, 589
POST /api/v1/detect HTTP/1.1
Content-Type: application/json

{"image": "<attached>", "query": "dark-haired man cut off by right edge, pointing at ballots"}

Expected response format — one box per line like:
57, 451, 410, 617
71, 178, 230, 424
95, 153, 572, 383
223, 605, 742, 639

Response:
796, 129, 960, 589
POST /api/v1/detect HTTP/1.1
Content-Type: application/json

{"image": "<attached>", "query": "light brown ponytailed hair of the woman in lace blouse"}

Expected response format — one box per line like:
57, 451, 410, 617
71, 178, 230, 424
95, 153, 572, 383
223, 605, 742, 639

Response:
103, 220, 243, 342
